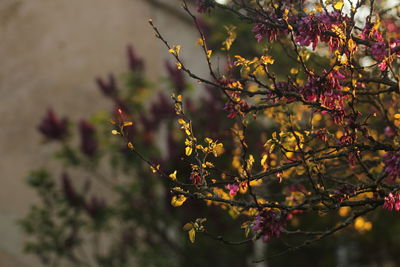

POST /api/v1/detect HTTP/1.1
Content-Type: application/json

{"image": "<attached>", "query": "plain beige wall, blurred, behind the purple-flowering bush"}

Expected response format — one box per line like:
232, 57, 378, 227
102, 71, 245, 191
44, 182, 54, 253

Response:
0, 0, 206, 267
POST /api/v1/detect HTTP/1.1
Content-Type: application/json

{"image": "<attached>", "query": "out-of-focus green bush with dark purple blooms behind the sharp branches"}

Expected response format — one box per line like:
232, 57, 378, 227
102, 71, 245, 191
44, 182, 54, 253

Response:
19, 1, 400, 266
